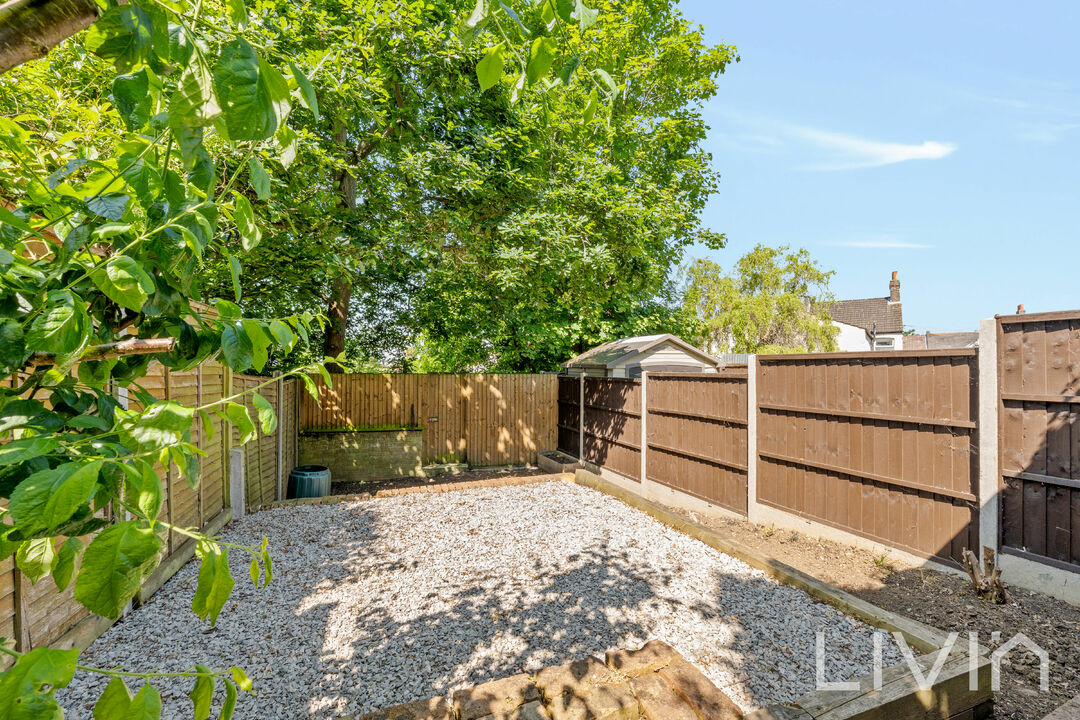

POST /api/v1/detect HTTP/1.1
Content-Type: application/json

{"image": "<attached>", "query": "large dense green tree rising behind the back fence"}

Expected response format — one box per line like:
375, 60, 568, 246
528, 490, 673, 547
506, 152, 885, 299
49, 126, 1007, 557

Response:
196, 0, 734, 370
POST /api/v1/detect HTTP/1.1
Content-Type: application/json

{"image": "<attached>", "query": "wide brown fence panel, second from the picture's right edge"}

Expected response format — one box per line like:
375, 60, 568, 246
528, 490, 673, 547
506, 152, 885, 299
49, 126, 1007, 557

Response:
757, 350, 978, 561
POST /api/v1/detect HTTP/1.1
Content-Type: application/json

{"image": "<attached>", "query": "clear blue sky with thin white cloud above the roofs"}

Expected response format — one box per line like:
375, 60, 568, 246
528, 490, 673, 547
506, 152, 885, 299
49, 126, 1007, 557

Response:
680, 0, 1080, 332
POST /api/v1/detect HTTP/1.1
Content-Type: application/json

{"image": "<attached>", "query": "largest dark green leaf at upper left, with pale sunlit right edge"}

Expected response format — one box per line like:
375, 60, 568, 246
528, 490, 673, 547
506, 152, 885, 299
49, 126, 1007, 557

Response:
214, 38, 289, 140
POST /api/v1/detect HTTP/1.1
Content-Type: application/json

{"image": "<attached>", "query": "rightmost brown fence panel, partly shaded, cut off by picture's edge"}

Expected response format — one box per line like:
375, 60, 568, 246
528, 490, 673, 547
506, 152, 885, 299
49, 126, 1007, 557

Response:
998, 311, 1080, 571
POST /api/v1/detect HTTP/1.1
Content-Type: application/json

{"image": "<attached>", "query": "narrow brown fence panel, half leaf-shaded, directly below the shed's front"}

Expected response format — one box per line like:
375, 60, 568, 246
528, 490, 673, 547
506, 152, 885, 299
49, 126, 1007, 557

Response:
581, 378, 642, 480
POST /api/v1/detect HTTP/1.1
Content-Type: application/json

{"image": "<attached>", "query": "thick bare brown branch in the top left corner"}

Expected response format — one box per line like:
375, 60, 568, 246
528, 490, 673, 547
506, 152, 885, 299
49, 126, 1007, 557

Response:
0, 0, 97, 74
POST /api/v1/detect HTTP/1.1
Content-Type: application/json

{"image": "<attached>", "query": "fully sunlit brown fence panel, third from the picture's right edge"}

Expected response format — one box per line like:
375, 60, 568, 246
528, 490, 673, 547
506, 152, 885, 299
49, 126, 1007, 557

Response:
645, 375, 747, 515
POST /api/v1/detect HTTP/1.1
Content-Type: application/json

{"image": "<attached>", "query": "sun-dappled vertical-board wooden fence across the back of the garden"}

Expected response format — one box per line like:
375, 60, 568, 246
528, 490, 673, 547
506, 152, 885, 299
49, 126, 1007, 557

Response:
298, 373, 558, 465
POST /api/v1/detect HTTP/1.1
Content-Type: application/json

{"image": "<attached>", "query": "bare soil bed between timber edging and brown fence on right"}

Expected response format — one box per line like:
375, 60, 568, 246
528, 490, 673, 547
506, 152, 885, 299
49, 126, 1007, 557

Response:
656, 507, 1080, 720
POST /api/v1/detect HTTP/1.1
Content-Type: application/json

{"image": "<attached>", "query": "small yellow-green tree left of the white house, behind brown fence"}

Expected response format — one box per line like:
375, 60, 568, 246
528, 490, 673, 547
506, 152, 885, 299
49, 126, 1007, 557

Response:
683, 245, 837, 353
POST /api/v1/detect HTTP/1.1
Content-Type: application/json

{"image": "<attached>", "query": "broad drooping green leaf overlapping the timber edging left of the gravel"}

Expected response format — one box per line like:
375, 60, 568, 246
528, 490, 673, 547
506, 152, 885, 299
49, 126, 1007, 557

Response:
75, 520, 161, 619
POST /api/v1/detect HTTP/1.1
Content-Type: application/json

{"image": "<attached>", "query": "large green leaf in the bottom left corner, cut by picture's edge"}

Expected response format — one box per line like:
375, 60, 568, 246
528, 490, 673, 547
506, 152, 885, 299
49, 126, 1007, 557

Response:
0, 648, 79, 720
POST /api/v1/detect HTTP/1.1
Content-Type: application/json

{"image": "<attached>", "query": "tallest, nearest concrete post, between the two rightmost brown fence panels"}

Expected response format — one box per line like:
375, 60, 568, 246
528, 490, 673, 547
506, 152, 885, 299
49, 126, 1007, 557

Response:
977, 317, 1001, 558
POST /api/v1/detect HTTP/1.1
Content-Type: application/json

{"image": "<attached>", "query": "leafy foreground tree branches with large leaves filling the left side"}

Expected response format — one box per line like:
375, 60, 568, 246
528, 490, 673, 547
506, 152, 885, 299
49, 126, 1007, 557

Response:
0, 0, 609, 720
